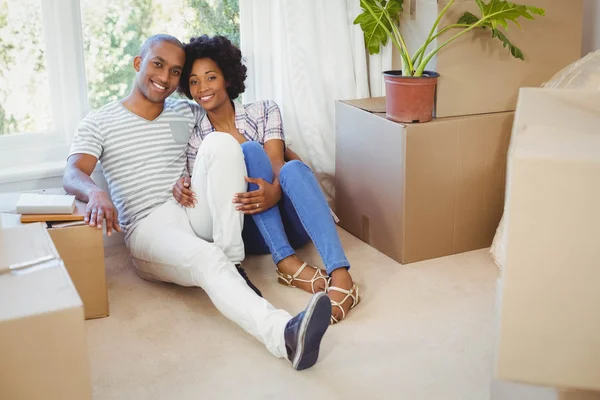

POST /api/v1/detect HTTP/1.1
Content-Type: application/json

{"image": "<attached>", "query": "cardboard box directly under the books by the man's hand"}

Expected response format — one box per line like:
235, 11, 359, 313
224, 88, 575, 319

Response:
3, 208, 109, 319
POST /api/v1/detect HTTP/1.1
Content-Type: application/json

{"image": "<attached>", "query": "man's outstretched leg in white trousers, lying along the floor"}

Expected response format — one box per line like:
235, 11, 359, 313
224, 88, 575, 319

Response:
127, 202, 291, 357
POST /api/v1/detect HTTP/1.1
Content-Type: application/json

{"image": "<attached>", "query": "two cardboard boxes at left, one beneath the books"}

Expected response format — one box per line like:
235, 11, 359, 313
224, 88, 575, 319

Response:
0, 193, 108, 400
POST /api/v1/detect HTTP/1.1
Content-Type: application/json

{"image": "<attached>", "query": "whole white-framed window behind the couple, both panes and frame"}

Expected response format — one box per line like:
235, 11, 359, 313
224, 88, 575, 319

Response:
0, 0, 240, 185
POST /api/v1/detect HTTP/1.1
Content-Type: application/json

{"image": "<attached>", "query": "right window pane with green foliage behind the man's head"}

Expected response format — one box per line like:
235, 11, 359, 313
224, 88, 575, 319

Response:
81, 0, 240, 109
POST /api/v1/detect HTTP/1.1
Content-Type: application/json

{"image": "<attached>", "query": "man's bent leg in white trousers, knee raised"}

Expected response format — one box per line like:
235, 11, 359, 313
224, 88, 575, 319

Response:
186, 132, 247, 264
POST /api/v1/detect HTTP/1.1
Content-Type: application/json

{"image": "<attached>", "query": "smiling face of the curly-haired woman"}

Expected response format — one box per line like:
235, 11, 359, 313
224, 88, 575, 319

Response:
189, 58, 230, 111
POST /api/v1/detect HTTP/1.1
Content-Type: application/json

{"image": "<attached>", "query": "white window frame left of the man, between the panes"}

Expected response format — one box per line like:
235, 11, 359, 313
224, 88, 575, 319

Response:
0, 0, 89, 183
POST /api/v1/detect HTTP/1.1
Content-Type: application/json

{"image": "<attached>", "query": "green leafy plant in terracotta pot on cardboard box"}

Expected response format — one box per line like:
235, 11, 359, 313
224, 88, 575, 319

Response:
354, 0, 545, 122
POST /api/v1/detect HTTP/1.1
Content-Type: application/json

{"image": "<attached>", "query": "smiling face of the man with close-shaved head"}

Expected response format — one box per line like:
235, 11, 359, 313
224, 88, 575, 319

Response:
133, 42, 185, 103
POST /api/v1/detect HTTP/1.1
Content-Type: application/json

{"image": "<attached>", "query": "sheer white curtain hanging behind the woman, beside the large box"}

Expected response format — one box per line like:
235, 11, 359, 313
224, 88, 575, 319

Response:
240, 0, 391, 201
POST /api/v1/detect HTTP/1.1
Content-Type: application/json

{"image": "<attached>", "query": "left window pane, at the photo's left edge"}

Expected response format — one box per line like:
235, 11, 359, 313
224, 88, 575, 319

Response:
0, 0, 53, 135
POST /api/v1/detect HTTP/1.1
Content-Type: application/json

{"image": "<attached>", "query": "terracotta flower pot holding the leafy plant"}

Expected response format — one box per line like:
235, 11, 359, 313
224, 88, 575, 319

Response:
383, 71, 440, 122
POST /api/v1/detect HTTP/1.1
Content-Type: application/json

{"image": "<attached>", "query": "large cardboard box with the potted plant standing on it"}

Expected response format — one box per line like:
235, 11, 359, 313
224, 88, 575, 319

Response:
335, 98, 513, 264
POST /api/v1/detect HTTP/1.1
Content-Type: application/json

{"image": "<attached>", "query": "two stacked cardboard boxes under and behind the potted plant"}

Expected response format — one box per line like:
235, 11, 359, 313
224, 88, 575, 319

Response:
335, 0, 582, 264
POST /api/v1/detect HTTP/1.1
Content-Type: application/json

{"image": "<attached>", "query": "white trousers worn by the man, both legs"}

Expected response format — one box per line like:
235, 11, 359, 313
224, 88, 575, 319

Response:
127, 132, 292, 358
